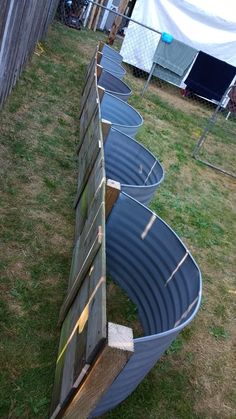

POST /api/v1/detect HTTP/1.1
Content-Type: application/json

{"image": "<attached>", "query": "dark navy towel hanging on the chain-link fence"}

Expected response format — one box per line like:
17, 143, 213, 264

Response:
184, 51, 236, 101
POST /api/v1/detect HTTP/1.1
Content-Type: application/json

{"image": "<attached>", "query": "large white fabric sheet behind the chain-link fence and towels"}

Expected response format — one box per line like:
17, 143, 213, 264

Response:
121, 0, 236, 72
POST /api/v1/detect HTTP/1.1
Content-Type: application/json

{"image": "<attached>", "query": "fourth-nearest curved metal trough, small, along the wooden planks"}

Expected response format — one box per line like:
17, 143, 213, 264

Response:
98, 69, 131, 102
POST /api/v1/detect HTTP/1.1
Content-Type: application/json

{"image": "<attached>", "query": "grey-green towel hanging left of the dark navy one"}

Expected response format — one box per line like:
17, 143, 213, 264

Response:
153, 39, 197, 86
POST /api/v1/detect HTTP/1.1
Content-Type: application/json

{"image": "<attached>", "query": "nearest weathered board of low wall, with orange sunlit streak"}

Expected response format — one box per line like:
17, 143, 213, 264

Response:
51, 246, 107, 417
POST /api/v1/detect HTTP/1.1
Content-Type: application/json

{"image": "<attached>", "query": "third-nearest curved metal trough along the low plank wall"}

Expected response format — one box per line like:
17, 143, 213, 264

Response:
101, 92, 143, 137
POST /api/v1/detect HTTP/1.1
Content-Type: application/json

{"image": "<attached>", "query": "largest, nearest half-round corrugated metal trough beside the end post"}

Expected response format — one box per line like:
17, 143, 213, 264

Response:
91, 193, 202, 417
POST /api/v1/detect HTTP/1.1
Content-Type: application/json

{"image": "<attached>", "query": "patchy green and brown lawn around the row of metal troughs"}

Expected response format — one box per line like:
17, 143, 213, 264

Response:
0, 23, 236, 419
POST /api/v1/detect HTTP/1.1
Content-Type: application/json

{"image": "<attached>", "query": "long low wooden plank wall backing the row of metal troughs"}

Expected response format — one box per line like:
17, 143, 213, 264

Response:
51, 44, 133, 419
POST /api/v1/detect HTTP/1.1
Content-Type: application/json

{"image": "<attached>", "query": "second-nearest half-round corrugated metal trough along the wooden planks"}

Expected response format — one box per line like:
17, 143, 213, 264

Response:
105, 128, 164, 204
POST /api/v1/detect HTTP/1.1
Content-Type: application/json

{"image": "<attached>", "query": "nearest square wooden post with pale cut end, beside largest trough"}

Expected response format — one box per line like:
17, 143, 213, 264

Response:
63, 323, 134, 419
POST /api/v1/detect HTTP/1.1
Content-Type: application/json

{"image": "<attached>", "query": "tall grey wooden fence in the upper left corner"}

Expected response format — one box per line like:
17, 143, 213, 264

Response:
0, 0, 59, 107
